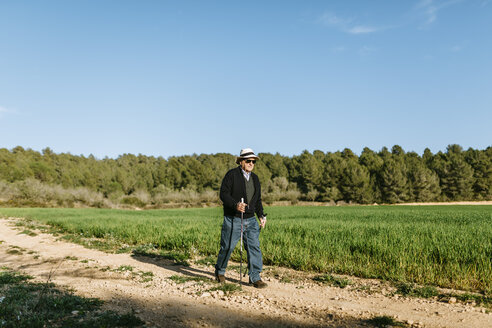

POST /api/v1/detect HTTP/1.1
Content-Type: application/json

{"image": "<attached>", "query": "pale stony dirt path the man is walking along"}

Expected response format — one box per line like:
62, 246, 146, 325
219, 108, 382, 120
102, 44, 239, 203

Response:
0, 219, 492, 328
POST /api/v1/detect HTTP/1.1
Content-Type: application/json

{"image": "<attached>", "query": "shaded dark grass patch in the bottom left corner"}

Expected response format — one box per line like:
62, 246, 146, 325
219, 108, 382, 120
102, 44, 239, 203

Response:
0, 267, 144, 328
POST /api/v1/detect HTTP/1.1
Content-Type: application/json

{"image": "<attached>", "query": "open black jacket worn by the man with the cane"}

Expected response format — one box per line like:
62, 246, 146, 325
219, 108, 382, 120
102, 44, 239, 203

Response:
220, 166, 264, 218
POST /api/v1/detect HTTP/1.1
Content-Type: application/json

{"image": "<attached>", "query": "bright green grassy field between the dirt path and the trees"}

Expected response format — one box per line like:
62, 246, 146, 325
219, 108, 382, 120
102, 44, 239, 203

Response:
0, 206, 492, 294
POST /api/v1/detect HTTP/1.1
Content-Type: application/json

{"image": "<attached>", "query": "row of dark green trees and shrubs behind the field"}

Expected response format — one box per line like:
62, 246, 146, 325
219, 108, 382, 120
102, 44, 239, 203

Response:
0, 144, 492, 207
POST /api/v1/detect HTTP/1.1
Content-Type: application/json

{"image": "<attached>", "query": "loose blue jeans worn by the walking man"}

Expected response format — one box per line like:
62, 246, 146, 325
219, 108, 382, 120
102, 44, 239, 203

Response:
215, 216, 263, 282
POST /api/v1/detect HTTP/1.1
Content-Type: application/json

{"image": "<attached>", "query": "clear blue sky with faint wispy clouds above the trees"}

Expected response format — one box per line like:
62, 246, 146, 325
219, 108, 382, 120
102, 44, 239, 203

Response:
0, 0, 492, 158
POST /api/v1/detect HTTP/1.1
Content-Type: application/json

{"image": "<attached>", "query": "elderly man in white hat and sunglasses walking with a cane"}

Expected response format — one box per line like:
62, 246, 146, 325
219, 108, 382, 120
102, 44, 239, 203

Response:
215, 148, 267, 288
